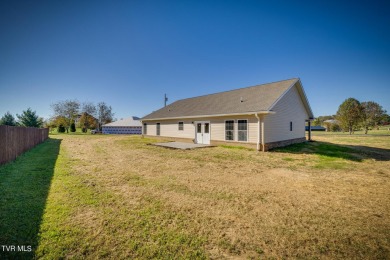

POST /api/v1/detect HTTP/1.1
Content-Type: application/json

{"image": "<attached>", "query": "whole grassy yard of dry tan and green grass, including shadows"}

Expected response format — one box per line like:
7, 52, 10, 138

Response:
0, 133, 390, 259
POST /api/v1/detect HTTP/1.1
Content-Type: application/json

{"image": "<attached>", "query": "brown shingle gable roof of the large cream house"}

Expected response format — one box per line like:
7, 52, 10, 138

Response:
141, 78, 313, 120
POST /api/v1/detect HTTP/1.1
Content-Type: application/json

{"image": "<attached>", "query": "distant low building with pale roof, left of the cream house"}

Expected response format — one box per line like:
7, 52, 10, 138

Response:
102, 116, 142, 135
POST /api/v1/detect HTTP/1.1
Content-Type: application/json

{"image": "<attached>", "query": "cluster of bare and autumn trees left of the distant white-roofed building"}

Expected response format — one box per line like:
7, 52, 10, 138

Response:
48, 100, 114, 133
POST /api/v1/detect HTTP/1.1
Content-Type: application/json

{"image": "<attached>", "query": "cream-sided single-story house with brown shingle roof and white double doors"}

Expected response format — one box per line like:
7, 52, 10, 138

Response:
141, 78, 313, 151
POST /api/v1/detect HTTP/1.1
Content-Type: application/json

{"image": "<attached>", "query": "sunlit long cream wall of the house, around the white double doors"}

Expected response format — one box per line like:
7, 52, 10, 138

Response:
142, 115, 257, 143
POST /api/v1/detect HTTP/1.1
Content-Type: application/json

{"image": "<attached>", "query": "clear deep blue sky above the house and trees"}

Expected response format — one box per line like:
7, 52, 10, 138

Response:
0, 0, 390, 119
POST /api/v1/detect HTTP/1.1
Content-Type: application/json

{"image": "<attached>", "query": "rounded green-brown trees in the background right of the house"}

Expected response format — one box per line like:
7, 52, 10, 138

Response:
313, 98, 390, 134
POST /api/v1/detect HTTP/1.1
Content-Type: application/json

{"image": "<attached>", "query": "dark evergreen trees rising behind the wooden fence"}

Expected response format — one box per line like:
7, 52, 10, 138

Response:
0, 108, 44, 127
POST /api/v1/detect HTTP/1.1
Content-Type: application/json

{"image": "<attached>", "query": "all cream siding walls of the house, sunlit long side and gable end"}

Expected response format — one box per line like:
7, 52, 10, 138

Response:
143, 86, 309, 147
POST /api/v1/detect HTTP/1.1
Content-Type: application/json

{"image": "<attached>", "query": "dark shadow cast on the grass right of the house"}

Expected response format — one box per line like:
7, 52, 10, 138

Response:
273, 141, 390, 162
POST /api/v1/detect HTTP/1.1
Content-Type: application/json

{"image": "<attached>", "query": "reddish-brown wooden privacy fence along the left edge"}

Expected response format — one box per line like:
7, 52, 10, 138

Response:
0, 125, 49, 165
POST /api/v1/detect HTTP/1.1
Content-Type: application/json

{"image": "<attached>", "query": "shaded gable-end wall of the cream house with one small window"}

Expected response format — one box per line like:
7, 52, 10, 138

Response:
264, 86, 309, 144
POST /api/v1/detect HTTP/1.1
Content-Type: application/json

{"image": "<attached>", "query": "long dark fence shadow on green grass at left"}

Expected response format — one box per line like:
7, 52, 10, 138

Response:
0, 138, 61, 259
